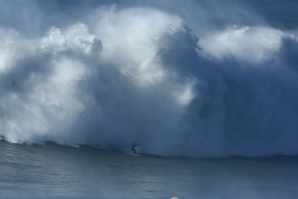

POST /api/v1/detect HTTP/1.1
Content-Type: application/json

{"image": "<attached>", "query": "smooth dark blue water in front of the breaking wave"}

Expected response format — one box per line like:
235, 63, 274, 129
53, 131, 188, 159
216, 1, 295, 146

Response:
0, 142, 298, 199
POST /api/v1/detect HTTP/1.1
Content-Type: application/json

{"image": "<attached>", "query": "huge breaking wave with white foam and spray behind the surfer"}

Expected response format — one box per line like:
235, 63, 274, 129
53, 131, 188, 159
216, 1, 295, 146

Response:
0, 1, 298, 158
